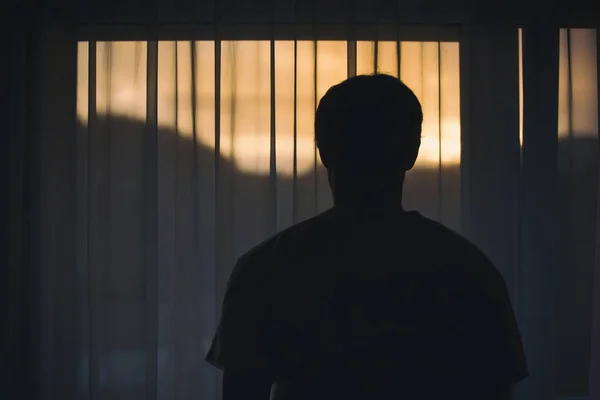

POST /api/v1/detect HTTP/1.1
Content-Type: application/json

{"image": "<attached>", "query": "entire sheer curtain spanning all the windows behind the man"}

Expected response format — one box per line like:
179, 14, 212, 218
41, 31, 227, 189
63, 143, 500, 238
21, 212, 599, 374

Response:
28, 29, 598, 400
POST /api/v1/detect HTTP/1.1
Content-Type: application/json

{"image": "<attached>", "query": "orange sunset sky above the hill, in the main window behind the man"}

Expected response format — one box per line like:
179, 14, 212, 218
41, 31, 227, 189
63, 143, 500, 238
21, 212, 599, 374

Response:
77, 41, 460, 176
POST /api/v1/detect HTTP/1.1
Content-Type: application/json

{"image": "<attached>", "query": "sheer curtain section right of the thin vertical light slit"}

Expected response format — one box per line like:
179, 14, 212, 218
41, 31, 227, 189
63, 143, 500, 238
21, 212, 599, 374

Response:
517, 26, 599, 399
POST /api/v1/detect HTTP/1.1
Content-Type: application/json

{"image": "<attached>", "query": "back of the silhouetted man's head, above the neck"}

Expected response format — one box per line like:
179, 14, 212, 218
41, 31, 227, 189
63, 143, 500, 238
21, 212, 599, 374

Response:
315, 74, 423, 174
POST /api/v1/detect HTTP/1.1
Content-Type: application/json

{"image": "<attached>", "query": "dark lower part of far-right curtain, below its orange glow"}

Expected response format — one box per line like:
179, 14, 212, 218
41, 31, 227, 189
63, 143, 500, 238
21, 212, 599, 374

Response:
555, 134, 598, 396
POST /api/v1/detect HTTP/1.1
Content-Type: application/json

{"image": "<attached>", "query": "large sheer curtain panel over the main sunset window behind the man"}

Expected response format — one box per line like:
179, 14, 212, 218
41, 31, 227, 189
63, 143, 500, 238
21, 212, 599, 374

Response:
34, 41, 461, 400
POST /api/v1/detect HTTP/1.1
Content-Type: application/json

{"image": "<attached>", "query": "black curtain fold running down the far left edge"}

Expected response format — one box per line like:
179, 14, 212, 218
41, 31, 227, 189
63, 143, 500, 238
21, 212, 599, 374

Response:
0, 7, 41, 398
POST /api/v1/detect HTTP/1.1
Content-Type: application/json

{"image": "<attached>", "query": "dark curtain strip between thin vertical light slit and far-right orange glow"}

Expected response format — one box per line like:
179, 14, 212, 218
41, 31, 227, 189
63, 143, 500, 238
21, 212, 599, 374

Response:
519, 26, 560, 399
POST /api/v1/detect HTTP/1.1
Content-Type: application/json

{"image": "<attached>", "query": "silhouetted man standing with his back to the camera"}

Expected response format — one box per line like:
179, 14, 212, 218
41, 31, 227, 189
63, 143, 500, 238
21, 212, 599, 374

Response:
207, 75, 527, 400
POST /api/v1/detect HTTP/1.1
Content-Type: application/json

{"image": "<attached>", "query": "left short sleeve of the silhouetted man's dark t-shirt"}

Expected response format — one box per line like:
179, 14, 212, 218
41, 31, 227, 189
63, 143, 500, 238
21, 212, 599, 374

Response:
205, 259, 269, 372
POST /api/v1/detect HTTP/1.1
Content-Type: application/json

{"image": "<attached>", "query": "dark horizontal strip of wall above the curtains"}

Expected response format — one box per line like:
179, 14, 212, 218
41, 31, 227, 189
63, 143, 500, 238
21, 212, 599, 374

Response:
30, 0, 598, 24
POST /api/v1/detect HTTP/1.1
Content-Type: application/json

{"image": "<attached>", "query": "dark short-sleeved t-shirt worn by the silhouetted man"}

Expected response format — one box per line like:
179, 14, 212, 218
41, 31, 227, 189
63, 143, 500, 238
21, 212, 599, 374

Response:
206, 207, 528, 400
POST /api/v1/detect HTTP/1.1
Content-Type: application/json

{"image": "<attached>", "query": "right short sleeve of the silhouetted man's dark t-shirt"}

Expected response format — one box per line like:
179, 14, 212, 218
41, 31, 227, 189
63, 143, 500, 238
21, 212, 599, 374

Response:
472, 265, 529, 386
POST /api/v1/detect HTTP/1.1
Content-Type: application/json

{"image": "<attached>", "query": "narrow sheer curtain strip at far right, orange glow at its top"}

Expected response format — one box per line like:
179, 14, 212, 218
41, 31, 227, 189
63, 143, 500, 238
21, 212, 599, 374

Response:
554, 29, 600, 396
